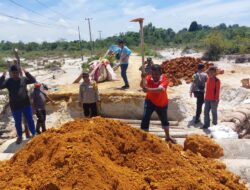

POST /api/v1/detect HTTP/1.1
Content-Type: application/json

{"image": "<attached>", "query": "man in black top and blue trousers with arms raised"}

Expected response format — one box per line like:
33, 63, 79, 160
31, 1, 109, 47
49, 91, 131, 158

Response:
0, 65, 36, 144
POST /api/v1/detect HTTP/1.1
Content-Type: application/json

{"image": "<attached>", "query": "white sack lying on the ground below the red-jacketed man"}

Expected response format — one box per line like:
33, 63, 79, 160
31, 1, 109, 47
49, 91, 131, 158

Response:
208, 125, 238, 139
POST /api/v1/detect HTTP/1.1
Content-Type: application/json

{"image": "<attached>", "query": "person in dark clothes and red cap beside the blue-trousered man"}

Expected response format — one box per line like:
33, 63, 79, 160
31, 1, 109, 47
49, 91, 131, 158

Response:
31, 83, 55, 134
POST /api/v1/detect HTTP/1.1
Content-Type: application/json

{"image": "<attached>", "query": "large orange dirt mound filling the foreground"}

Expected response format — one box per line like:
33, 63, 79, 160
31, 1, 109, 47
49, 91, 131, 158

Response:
0, 117, 246, 190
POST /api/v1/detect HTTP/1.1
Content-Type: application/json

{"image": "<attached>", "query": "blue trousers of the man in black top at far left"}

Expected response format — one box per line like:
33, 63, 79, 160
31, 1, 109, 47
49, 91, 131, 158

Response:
11, 106, 36, 137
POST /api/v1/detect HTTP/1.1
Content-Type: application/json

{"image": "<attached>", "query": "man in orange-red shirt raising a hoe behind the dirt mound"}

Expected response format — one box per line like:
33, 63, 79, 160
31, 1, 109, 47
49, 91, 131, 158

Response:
141, 64, 176, 143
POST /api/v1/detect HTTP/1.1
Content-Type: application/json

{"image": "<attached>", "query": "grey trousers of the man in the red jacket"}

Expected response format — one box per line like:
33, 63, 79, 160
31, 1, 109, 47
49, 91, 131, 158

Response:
204, 100, 219, 128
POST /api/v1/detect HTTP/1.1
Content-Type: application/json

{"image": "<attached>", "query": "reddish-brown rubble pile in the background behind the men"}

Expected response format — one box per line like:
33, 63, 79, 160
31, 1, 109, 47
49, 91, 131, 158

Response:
161, 57, 224, 86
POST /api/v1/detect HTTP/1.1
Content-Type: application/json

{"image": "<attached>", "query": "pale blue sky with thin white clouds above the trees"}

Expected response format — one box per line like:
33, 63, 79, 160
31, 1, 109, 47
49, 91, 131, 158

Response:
0, 0, 250, 42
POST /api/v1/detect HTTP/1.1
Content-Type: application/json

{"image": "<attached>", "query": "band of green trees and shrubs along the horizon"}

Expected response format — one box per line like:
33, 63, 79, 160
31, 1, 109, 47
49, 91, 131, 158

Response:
0, 21, 250, 61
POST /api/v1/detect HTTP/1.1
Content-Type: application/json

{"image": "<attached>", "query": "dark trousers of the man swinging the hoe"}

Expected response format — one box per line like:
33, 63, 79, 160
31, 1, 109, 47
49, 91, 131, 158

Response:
141, 100, 169, 131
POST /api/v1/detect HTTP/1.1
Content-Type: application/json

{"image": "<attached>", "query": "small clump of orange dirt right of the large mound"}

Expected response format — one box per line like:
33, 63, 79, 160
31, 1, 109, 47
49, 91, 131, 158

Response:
184, 135, 224, 158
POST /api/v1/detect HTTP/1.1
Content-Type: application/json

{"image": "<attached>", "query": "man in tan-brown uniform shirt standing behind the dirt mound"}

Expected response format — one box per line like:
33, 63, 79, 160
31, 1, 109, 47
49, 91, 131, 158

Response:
79, 73, 100, 117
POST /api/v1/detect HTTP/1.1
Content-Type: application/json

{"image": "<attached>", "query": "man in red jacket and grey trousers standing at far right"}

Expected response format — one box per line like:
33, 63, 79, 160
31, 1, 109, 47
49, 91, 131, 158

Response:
203, 66, 221, 129
